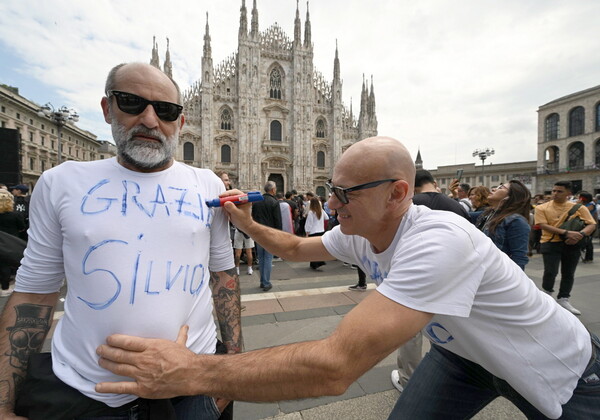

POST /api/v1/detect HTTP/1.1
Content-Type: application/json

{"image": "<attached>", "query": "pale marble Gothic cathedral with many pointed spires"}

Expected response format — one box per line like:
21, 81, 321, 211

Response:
151, 0, 377, 195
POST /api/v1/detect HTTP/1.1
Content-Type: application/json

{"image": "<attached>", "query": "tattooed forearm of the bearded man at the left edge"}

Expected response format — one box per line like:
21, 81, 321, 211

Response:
0, 292, 58, 411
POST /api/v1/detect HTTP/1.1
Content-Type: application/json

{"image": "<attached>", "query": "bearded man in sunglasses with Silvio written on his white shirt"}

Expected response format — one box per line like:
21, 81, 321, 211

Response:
0, 63, 242, 420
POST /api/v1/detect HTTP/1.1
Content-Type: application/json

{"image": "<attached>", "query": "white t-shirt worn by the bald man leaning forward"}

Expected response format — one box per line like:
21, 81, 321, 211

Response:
323, 205, 591, 418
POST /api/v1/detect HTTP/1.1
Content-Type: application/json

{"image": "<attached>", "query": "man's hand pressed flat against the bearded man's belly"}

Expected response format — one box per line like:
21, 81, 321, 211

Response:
96, 325, 196, 398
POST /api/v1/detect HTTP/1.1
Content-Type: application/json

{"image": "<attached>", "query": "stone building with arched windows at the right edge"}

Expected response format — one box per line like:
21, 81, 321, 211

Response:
537, 86, 600, 194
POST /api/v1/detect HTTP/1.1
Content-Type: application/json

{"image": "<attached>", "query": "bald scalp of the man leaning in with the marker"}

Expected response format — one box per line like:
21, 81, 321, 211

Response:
334, 137, 415, 191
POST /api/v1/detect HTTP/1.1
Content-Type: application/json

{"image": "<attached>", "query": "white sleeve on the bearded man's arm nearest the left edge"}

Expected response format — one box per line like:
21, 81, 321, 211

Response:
15, 171, 65, 293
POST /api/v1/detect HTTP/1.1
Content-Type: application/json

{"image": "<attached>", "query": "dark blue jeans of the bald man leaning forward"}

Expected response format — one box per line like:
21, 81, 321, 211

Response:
388, 335, 600, 420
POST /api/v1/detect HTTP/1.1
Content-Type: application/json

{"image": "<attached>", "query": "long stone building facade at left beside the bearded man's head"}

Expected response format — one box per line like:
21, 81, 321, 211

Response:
0, 84, 116, 187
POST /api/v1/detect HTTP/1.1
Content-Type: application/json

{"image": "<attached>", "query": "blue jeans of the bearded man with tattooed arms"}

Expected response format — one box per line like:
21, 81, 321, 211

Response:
77, 395, 221, 420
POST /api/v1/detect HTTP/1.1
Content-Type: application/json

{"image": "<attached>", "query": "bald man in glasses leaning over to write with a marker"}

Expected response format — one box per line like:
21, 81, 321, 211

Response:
97, 137, 600, 419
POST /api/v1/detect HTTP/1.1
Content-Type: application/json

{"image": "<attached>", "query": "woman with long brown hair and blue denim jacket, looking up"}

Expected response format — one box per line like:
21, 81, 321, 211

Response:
477, 180, 531, 270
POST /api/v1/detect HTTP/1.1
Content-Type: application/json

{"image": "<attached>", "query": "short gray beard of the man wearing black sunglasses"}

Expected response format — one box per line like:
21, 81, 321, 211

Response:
111, 120, 179, 170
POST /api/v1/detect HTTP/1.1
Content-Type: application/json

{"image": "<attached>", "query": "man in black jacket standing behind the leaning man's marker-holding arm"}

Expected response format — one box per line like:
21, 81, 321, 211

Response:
252, 181, 281, 292
